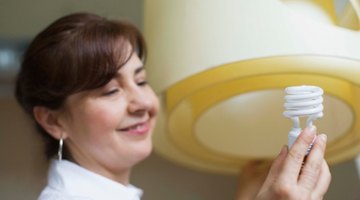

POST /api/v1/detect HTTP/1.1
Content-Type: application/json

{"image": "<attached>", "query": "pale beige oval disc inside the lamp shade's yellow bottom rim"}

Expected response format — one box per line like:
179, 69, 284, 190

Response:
194, 89, 354, 158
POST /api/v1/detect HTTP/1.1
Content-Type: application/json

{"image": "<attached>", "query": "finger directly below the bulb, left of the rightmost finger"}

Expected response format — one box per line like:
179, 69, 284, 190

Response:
280, 128, 316, 184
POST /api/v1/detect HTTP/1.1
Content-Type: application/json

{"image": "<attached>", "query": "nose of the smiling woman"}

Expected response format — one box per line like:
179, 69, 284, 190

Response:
128, 86, 154, 115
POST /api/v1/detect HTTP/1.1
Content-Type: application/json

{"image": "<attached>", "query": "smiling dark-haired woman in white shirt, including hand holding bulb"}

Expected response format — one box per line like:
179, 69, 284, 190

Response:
16, 13, 330, 200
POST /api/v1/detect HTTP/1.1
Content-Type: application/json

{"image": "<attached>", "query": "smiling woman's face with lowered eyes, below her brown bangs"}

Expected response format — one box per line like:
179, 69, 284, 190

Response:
60, 50, 159, 182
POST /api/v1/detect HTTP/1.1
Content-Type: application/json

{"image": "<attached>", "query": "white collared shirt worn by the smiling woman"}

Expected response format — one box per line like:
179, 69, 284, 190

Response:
38, 160, 143, 200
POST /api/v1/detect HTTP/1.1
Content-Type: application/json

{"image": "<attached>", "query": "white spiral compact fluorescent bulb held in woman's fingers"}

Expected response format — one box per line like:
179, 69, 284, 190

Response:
283, 85, 324, 149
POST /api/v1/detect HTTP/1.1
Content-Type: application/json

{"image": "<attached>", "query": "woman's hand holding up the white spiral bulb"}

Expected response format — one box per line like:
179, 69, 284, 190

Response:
255, 129, 331, 200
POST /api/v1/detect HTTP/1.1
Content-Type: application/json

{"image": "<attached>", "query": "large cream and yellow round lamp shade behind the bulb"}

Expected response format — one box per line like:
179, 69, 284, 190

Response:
144, 0, 360, 174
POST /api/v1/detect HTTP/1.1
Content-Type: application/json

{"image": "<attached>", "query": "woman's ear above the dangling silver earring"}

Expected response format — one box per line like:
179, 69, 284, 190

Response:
33, 106, 66, 139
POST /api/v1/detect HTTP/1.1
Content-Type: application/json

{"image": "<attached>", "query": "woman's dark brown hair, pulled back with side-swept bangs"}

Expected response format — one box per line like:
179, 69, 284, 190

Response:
15, 13, 146, 158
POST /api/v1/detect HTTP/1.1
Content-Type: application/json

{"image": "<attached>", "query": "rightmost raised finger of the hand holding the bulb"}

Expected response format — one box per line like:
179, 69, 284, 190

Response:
299, 134, 327, 191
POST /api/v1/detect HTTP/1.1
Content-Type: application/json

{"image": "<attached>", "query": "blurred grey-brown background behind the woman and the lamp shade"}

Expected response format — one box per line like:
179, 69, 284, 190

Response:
0, 0, 360, 200
